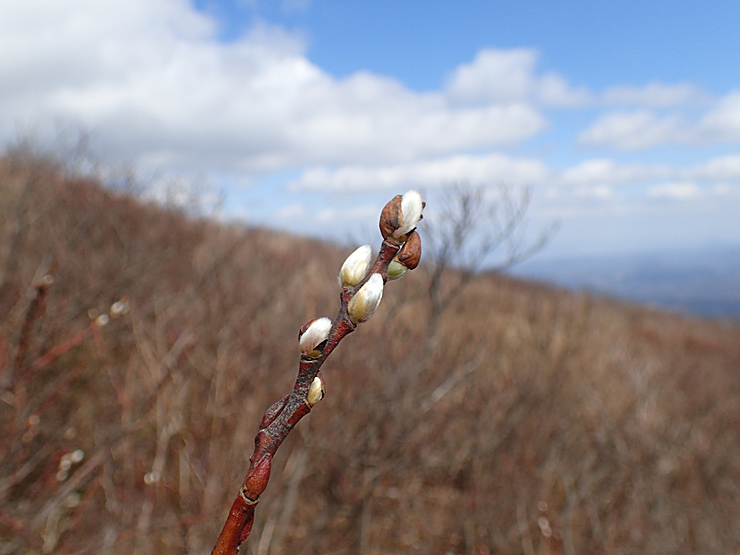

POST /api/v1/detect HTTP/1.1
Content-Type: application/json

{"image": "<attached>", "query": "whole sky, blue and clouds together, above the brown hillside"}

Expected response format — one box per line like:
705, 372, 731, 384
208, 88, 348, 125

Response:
0, 0, 740, 256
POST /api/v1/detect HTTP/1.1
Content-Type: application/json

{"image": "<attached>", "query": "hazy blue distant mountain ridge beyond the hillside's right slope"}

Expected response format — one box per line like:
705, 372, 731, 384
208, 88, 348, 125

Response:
511, 247, 740, 320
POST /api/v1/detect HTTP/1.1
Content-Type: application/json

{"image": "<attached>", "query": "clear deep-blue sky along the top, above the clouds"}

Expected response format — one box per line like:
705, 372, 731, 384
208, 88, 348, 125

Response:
195, 0, 740, 90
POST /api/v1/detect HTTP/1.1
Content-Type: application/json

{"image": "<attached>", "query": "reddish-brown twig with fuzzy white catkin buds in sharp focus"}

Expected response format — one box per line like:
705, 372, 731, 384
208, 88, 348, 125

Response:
212, 191, 424, 555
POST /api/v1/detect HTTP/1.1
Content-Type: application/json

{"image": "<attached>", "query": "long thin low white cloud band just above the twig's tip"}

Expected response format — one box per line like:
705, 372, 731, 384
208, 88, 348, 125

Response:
289, 153, 740, 218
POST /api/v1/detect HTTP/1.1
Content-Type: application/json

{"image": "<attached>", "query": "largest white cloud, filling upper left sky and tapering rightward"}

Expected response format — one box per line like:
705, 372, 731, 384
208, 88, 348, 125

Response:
0, 0, 548, 174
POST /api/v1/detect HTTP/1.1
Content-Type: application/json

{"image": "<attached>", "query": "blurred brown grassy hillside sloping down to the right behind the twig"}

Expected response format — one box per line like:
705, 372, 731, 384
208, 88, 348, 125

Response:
0, 153, 740, 555
